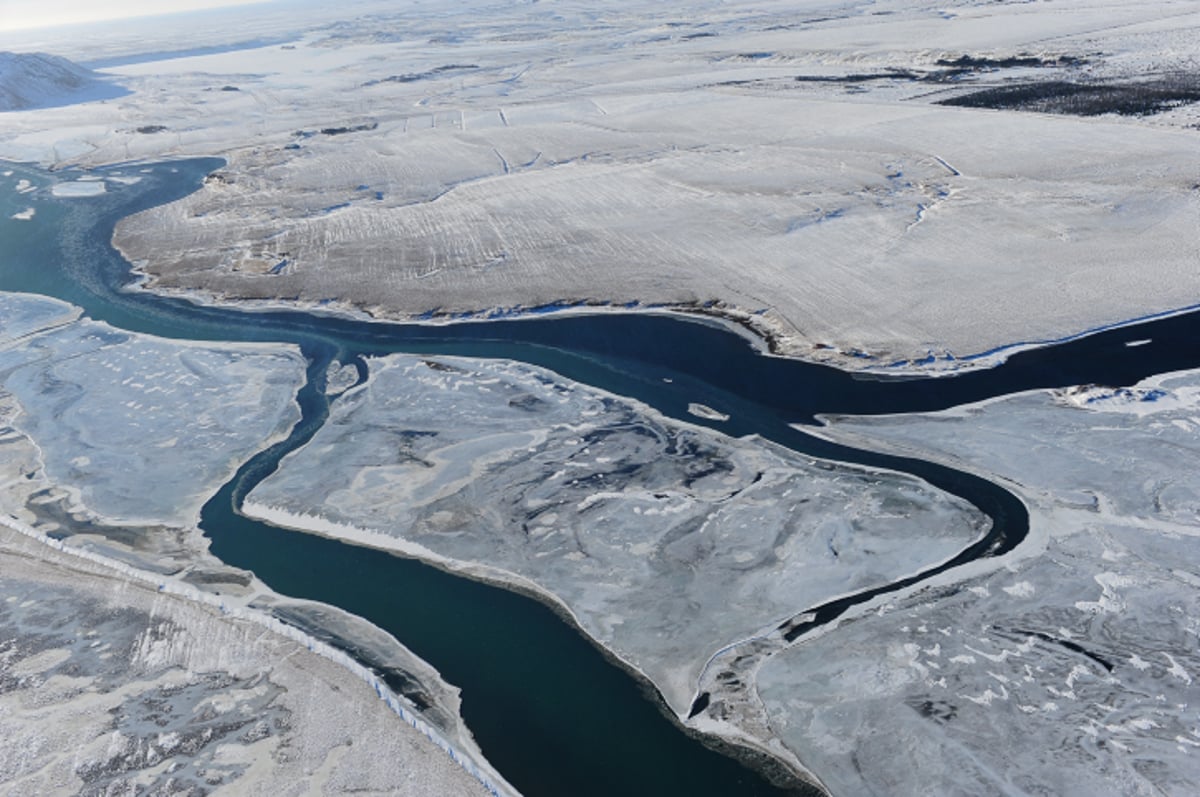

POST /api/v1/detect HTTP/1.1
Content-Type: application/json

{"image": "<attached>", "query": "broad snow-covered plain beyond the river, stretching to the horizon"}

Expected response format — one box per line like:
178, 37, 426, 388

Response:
0, 0, 1200, 368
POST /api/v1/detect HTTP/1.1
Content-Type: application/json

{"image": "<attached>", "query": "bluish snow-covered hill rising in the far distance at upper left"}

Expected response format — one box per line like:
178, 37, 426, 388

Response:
0, 53, 127, 112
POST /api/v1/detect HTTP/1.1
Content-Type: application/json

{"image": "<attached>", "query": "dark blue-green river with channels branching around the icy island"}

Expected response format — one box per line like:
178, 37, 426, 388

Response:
0, 158, 1200, 797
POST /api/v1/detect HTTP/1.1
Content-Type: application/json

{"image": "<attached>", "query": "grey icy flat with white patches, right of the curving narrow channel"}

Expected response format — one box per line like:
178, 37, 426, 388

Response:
782, 371, 1200, 796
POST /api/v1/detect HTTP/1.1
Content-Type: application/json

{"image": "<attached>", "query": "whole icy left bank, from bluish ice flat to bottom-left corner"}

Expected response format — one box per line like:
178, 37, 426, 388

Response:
0, 293, 506, 795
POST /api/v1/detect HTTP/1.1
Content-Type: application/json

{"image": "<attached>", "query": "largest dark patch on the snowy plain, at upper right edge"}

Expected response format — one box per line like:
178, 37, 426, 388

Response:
938, 74, 1200, 116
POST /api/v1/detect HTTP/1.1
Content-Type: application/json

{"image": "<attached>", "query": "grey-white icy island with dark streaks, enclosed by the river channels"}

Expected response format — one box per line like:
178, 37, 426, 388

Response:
245, 355, 988, 771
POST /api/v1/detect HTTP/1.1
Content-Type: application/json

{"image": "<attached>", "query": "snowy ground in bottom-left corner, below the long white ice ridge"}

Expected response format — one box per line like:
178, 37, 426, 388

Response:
0, 517, 515, 797
